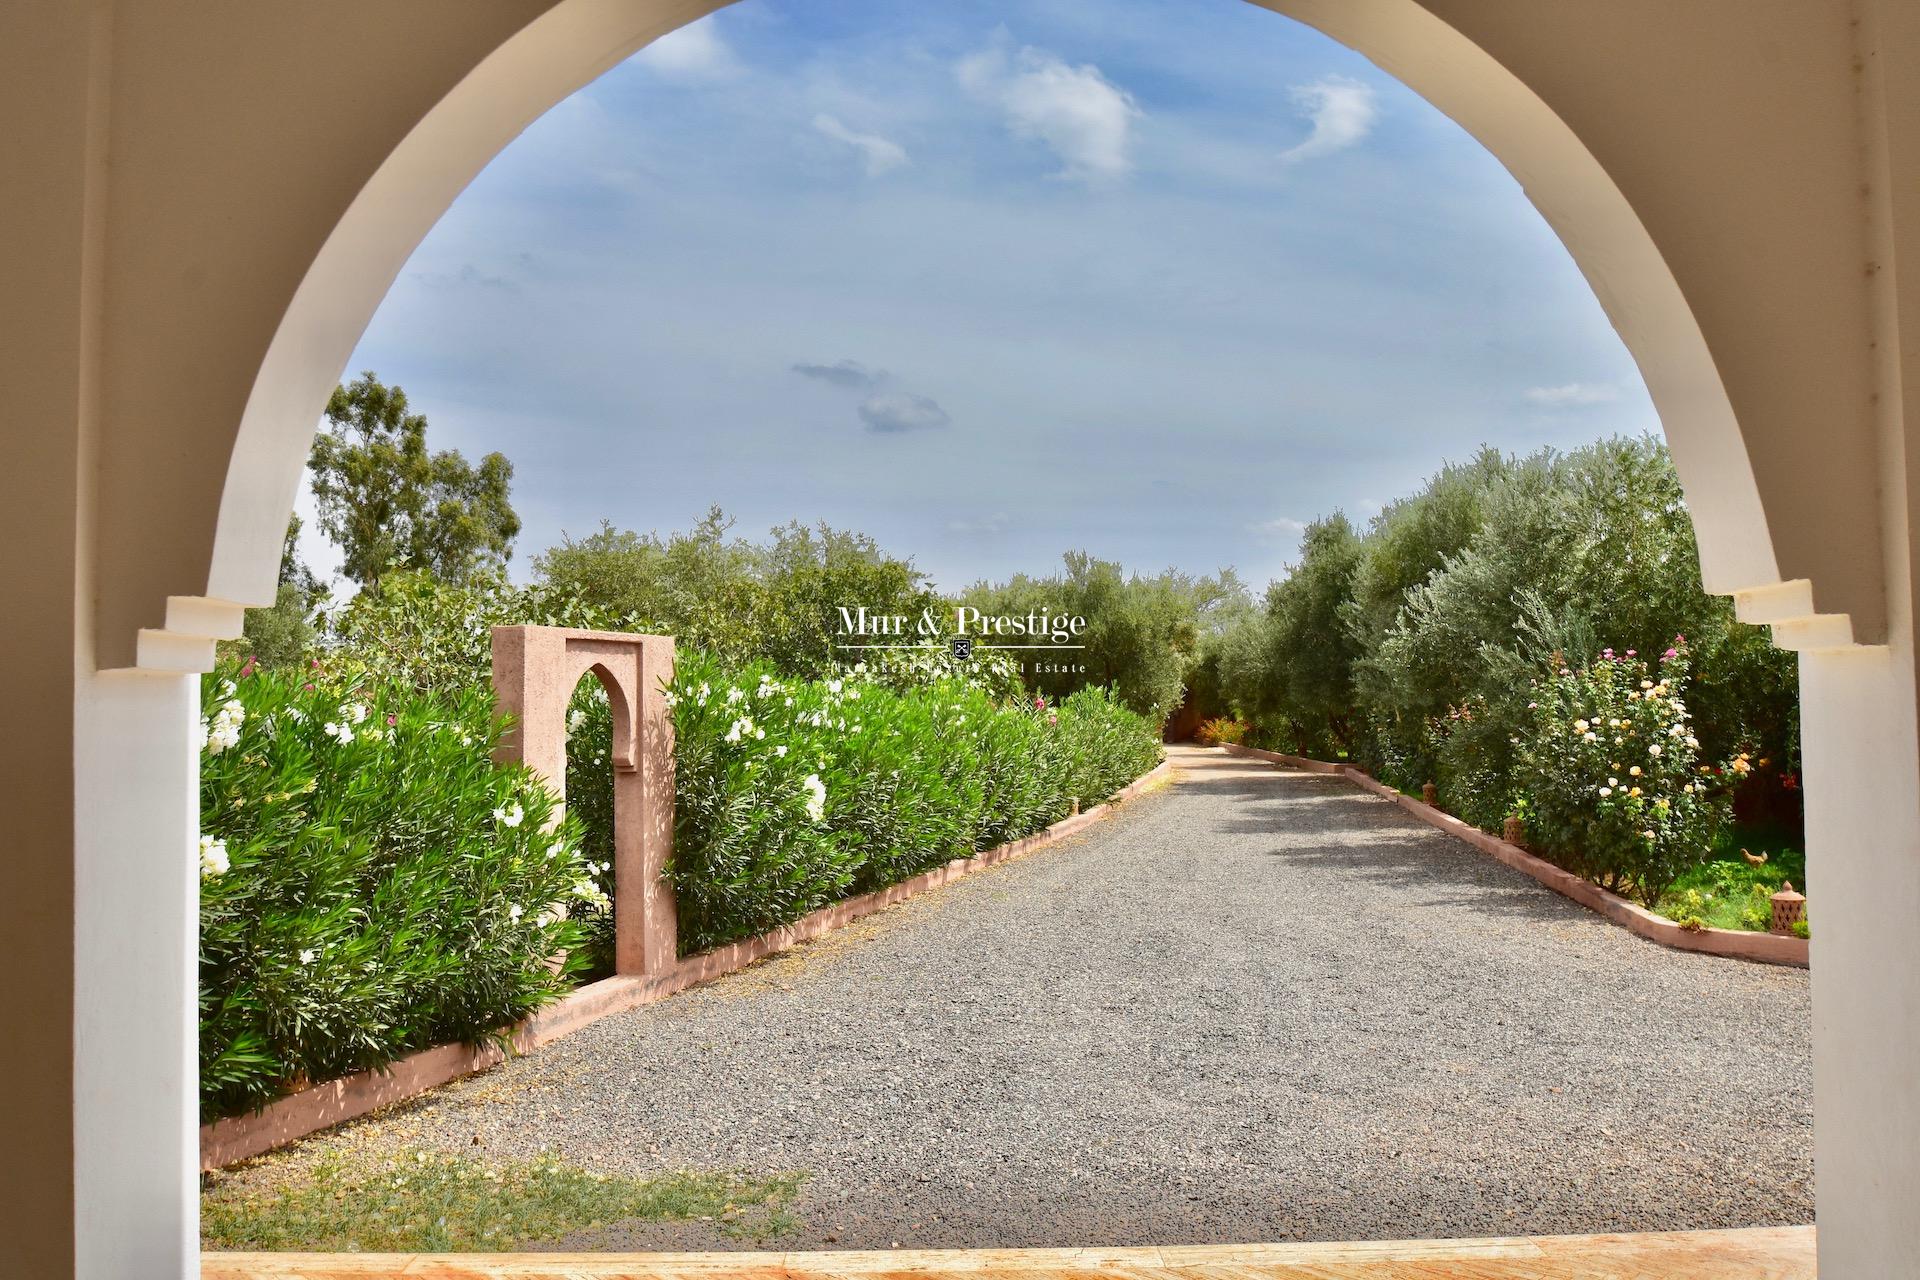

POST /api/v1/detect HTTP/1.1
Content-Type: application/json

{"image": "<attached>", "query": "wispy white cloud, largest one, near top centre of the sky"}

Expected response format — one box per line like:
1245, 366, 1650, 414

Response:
954, 36, 1140, 180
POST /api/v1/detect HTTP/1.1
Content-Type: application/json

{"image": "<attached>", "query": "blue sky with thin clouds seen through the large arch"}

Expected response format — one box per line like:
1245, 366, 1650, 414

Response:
317, 0, 1657, 587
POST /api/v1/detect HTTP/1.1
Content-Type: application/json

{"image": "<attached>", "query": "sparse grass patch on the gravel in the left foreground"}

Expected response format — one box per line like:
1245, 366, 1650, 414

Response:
200, 1151, 806, 1253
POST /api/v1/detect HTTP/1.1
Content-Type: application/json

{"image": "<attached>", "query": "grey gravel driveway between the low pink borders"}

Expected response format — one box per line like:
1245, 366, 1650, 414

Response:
228, 750, 1812, 1249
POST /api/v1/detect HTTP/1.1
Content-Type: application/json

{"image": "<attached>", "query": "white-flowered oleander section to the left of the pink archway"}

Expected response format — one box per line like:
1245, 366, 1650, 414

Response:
200, 666, 595, 1117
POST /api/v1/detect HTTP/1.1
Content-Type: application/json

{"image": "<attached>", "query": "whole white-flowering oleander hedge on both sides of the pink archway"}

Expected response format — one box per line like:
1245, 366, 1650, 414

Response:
200, 652, 1162, 1119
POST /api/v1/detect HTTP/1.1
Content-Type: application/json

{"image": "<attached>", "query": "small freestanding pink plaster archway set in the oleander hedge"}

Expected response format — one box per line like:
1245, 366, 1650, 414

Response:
493, 628, 680, 977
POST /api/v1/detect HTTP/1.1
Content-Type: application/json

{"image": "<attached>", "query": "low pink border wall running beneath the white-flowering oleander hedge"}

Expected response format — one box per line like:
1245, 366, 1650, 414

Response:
200, 760, 1173, 1169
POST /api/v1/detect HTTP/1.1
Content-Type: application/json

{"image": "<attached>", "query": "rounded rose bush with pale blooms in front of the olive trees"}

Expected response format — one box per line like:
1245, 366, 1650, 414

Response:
1517, 639, 1749, 906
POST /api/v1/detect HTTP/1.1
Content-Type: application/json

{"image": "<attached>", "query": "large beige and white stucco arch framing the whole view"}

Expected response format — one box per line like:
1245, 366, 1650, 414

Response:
0, 0, 1920, 1280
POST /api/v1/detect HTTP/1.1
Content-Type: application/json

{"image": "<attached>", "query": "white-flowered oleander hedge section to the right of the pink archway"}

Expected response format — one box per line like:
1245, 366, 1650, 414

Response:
652, 652, 1160, 952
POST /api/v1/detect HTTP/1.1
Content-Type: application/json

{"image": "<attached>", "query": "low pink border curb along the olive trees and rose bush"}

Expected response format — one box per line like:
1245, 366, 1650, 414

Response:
1227, 747, 1809, 969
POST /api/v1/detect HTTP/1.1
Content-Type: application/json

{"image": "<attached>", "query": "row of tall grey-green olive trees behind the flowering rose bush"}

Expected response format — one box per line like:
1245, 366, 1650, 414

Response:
1219, 438, 1799, 825
